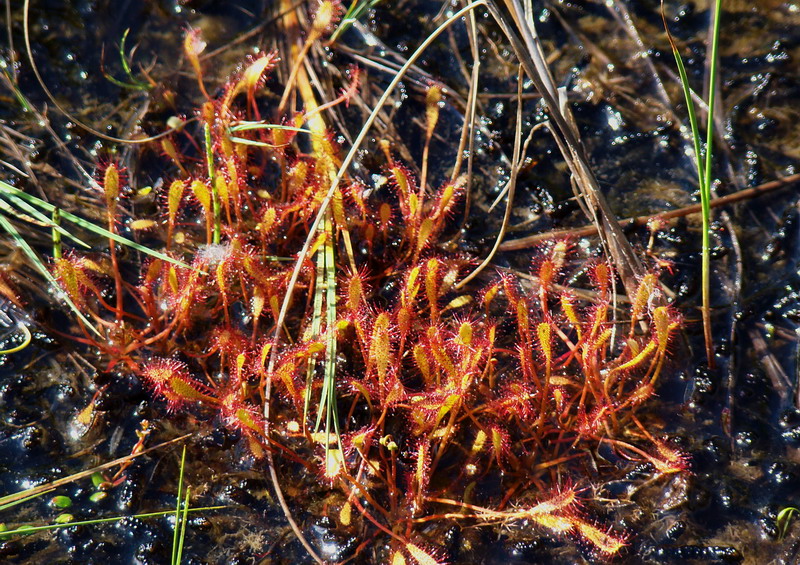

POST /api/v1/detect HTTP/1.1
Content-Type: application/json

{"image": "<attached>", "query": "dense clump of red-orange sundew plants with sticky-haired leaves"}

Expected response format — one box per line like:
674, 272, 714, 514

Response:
23, 3, 687, 563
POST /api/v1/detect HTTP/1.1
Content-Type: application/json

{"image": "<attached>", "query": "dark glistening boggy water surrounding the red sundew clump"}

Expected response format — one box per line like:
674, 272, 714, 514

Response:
0, 1, 800, 564
